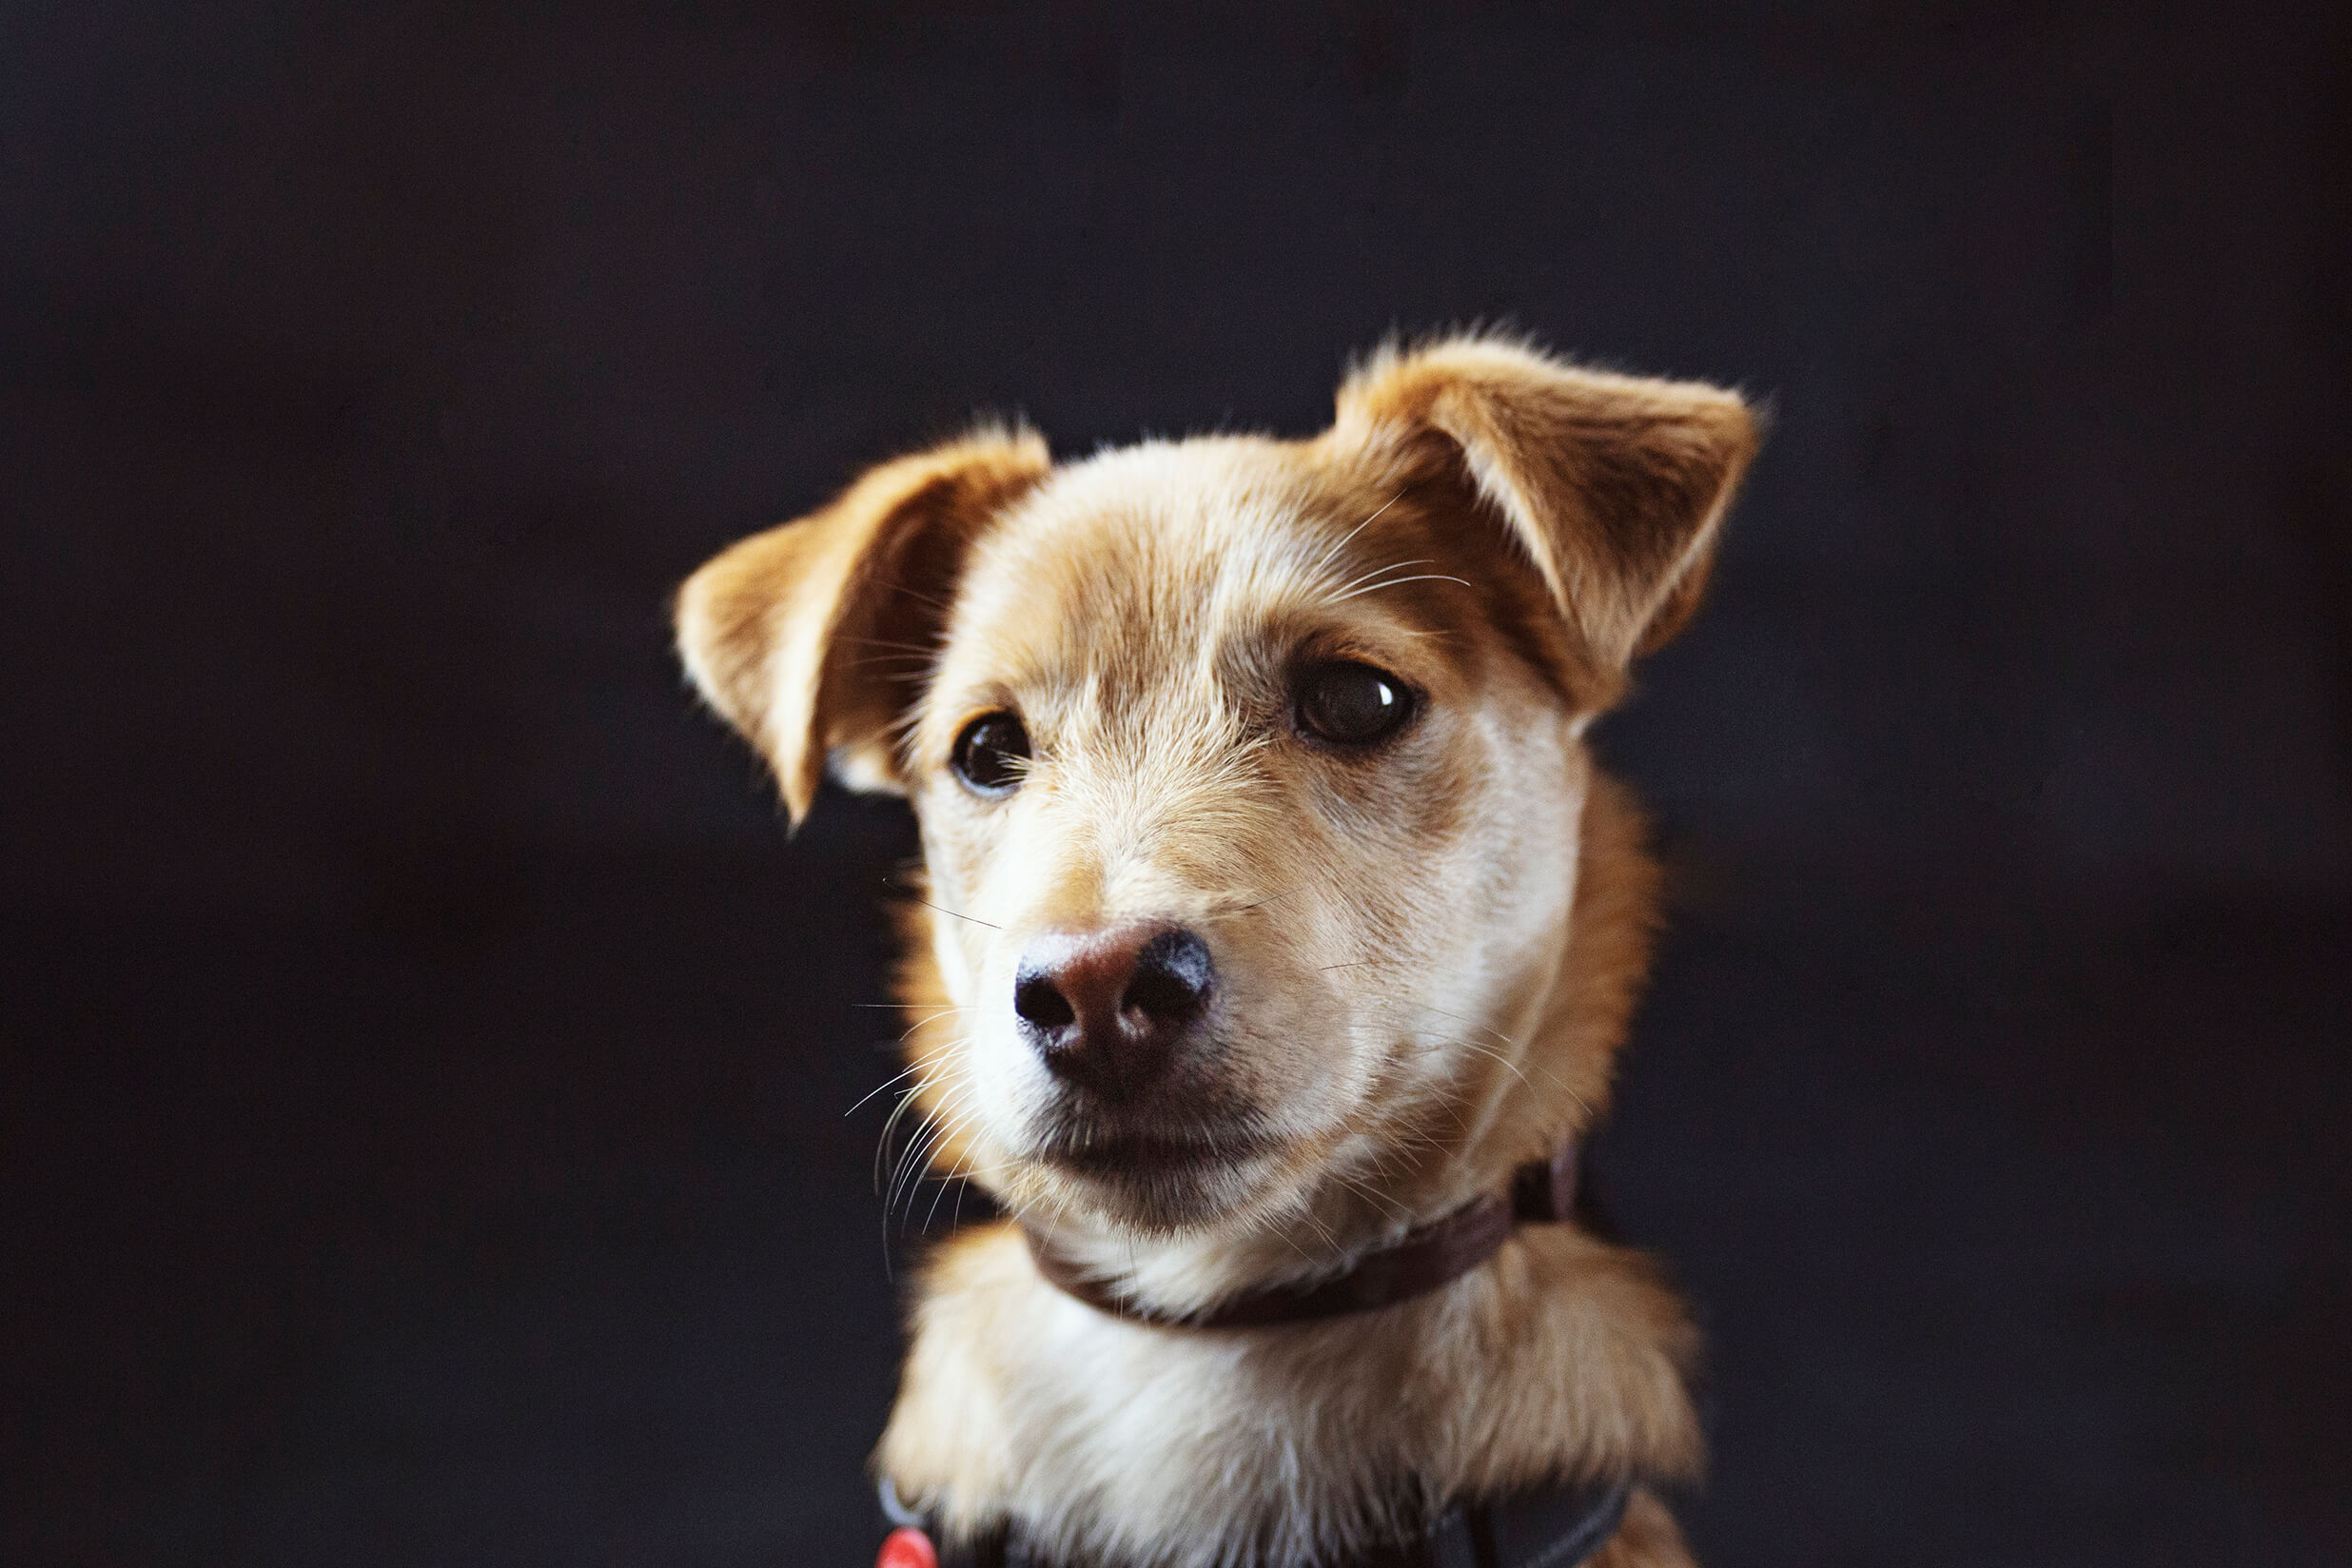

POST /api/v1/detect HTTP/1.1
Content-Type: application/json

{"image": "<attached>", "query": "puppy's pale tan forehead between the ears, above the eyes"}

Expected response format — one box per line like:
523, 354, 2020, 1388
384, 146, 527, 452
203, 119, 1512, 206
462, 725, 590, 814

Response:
948, 438, 1379, 679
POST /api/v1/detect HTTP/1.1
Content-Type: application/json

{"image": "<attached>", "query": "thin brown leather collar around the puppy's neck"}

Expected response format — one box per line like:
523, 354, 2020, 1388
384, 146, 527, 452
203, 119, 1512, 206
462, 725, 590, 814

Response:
1021, 1143, 1576, 1328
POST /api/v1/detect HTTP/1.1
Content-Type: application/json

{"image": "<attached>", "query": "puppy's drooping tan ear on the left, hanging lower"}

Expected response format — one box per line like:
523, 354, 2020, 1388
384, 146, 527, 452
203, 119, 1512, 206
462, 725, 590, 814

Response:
677, 430, 1051, 825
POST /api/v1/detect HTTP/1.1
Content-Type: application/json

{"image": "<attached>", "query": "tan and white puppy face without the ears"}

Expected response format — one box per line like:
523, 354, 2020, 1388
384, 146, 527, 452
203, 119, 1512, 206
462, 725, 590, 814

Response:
906, 440, 1583, 1225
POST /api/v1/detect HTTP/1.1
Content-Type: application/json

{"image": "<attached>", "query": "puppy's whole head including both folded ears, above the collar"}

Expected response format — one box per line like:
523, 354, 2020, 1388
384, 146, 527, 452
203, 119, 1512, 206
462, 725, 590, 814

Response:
677, 339, 1754, 1229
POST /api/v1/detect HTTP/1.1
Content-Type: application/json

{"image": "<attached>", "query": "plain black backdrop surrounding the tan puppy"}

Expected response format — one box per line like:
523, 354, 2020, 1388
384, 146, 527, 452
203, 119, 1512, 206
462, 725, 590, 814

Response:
0, 0, 2352, 1566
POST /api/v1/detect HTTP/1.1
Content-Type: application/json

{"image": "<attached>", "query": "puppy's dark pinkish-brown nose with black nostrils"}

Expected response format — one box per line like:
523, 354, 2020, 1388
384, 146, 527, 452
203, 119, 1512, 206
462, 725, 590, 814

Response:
1013, 926, 1216, 1098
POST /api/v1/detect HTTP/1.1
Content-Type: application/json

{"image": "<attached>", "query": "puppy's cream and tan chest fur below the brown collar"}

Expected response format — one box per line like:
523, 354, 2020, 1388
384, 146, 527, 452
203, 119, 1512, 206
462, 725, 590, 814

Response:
877, 1227, 1698, 1568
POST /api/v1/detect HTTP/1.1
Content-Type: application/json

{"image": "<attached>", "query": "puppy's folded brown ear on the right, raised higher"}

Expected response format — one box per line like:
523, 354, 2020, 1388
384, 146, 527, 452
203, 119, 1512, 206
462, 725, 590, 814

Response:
1331, 339, 1757, 686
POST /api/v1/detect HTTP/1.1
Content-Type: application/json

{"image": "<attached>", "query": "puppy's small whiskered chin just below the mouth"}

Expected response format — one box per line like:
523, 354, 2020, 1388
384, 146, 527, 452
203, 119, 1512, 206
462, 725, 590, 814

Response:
1030, 1133, 1284, 1234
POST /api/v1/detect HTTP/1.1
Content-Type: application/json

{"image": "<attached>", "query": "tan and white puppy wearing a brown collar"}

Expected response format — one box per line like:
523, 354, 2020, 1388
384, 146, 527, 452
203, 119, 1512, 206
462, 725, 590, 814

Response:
675, 334, 1759, 1568
